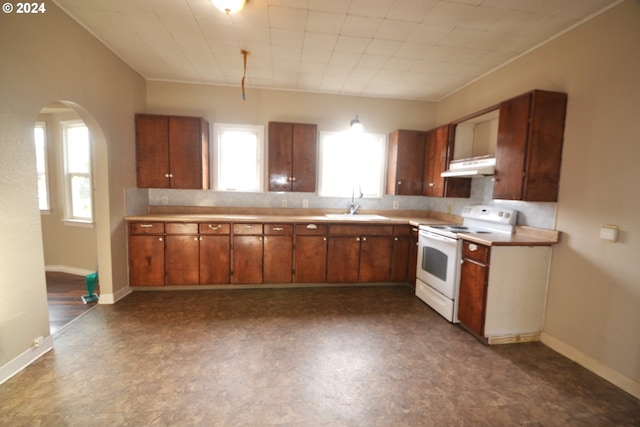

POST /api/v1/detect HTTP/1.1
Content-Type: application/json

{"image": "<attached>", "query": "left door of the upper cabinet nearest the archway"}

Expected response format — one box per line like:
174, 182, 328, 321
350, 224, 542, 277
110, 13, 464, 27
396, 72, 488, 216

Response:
135, 114, 171, 188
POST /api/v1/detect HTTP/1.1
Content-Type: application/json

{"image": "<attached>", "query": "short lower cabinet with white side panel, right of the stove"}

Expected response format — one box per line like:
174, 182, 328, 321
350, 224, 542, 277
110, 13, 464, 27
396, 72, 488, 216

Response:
458, 240, 551, 344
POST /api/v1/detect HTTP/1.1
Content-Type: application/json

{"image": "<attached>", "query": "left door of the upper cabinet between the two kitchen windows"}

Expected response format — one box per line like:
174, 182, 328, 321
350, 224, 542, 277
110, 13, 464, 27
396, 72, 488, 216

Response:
269, 122, 293, 191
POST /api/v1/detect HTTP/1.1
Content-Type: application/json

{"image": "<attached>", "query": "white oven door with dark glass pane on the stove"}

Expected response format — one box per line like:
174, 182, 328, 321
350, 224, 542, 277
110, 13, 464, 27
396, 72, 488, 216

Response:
416, 230, 460, 300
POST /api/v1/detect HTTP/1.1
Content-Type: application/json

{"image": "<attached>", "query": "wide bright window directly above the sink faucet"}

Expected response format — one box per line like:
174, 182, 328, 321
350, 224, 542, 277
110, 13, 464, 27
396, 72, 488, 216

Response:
319, 132, 386, 197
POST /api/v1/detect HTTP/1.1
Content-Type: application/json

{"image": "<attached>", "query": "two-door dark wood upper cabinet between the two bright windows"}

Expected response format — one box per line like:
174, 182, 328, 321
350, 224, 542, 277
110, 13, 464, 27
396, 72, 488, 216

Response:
269, 122, 318, 192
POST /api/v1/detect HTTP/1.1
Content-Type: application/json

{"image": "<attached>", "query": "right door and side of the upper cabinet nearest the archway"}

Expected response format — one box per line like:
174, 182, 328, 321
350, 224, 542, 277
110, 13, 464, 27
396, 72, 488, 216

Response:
169, 117, 209, 190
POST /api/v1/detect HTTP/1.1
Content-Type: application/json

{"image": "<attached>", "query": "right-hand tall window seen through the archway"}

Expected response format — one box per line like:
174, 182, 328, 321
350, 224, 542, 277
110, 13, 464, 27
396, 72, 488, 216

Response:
61, 121, 93, 222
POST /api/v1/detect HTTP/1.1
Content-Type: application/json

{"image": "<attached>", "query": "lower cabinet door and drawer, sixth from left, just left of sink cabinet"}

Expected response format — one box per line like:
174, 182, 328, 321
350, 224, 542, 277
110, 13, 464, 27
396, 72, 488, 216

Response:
294, 224, 327, 283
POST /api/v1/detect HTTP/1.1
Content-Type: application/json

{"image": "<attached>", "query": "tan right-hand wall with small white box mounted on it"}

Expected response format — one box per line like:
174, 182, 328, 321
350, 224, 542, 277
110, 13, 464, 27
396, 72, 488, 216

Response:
438, 0, 640, 397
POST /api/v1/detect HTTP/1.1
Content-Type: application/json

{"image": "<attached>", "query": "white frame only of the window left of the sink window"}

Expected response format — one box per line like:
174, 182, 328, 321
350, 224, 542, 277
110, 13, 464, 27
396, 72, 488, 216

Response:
210, 123, 266, 193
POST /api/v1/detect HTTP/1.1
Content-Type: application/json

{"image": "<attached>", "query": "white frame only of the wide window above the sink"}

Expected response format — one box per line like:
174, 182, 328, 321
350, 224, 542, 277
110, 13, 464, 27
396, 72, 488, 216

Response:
318, 130, 389, 199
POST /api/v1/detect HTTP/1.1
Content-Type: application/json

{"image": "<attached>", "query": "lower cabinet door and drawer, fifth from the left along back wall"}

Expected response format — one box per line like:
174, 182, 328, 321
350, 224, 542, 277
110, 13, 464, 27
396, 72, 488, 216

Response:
263, 224, 293, 283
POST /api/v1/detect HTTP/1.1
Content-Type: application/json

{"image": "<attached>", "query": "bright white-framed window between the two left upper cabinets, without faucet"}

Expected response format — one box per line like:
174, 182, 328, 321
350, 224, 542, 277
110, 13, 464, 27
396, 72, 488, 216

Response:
211, 123, 264, 192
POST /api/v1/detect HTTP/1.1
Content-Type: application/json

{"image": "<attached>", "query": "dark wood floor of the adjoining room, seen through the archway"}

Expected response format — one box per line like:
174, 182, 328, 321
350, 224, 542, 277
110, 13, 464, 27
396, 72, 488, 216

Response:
46, 271, 99, 334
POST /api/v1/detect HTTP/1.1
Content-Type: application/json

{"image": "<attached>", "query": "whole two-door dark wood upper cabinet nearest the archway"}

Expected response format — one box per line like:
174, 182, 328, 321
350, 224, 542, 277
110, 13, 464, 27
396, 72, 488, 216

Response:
136, 114, 209, 190
